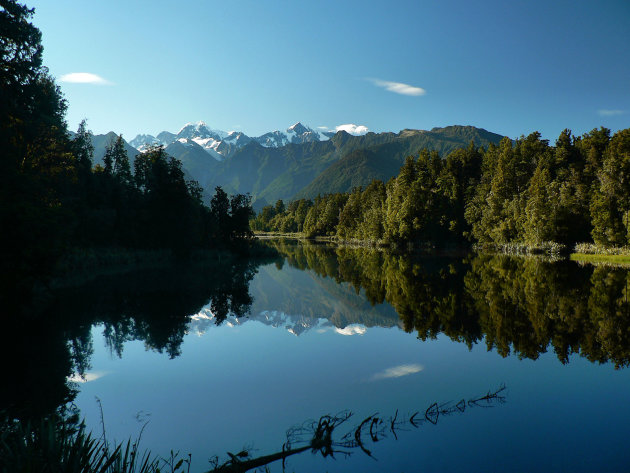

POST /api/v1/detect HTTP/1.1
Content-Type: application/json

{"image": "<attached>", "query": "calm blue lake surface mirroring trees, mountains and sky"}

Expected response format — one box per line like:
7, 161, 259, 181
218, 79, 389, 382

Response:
6, 241, 630, 472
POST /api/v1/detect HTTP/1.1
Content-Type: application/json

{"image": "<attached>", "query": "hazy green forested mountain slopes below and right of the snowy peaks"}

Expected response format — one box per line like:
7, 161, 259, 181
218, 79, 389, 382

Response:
200, 126, 502, 207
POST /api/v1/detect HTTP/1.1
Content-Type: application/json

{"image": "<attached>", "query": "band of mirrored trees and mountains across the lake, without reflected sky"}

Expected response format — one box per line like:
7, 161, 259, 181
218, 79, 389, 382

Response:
0, 240, 630, 416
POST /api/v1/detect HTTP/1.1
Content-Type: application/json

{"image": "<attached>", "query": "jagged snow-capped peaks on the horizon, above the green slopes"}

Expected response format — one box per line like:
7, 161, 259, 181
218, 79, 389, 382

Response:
130, 121, 331, 161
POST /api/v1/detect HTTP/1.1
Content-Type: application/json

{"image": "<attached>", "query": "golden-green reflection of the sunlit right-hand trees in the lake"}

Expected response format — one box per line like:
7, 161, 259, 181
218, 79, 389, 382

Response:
269, 240, 630, 368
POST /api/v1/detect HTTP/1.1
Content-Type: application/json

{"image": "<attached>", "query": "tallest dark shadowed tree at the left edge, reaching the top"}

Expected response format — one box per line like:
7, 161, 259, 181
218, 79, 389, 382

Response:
0, 0, 76, 302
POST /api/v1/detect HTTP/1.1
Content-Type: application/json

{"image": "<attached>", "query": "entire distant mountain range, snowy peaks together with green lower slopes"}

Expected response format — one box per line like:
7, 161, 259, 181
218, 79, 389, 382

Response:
86, 122, 503, 209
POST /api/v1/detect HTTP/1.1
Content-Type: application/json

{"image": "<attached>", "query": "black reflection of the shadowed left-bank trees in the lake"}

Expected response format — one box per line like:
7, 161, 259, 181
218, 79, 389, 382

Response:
0, 253, 274, 418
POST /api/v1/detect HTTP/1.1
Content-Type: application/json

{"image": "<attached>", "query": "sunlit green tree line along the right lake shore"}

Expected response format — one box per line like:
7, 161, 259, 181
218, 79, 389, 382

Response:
251, 128, 630, 247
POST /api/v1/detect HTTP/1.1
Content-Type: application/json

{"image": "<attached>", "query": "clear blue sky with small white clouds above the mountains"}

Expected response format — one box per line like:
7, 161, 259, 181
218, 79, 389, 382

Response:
27, 0, 630, 142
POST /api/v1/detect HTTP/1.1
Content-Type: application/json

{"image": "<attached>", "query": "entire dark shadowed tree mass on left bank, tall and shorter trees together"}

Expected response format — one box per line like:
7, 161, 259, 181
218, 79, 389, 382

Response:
0, 0, 252, 297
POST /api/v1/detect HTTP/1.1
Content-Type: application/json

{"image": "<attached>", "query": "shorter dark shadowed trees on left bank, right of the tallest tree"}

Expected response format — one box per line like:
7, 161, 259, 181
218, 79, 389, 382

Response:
70, 123, 253, 254
